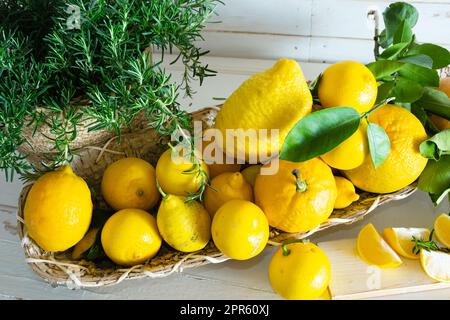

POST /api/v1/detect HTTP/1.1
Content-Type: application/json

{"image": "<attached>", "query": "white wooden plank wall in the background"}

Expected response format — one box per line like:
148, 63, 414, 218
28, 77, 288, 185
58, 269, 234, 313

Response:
202, 0, 450, 62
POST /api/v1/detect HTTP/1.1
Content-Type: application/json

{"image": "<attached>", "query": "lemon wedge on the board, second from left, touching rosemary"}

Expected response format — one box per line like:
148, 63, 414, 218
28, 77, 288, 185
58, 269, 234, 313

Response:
383, 228, 430, 259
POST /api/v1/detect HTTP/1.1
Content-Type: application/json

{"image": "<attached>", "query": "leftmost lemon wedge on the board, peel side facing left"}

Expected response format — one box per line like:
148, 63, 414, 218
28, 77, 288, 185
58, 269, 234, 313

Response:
356, 223, 402, 268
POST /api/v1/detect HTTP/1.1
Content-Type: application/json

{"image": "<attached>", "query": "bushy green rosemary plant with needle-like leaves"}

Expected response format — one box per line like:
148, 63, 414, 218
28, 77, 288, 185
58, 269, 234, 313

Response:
0, 0, 220, 200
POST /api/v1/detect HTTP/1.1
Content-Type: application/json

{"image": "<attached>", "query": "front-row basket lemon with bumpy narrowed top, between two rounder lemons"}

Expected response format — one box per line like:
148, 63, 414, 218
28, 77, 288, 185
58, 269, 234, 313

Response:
156, 194, 211, 252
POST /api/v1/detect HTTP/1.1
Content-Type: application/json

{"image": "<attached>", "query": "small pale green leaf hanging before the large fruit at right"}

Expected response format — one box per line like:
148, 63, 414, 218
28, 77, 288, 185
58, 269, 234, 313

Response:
367, 123, 391, 168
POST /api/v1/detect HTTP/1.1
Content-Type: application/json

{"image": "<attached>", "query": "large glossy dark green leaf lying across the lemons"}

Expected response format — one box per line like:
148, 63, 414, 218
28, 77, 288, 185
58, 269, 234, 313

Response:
280, 107, 361, 162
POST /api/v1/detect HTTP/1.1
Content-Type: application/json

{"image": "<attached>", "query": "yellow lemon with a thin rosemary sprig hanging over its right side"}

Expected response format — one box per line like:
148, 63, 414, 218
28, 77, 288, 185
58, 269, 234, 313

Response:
156, 148, 209, 196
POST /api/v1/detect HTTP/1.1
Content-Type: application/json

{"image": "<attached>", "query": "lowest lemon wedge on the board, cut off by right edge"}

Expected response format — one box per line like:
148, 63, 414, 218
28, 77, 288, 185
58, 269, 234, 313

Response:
419, 249, 450, 282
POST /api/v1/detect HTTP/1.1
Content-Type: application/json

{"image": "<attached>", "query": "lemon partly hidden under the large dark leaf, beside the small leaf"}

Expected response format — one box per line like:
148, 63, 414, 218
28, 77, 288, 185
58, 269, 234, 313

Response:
320, 122, 369, 170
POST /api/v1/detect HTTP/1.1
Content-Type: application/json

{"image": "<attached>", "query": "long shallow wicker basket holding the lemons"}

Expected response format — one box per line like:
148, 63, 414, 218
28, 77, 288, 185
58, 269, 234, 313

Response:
18, 107, 416, 288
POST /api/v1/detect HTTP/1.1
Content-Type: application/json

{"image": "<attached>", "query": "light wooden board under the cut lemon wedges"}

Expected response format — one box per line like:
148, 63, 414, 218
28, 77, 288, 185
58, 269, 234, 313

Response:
318, 239, 450, 300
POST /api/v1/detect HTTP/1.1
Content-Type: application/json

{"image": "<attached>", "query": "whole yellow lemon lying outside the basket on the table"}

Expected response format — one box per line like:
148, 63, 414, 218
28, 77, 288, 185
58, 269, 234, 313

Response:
269, 243, 331, 300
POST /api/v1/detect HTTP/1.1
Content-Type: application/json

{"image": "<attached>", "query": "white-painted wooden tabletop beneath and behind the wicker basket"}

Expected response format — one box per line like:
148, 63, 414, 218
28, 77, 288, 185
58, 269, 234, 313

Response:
0, 57, 450, 299
